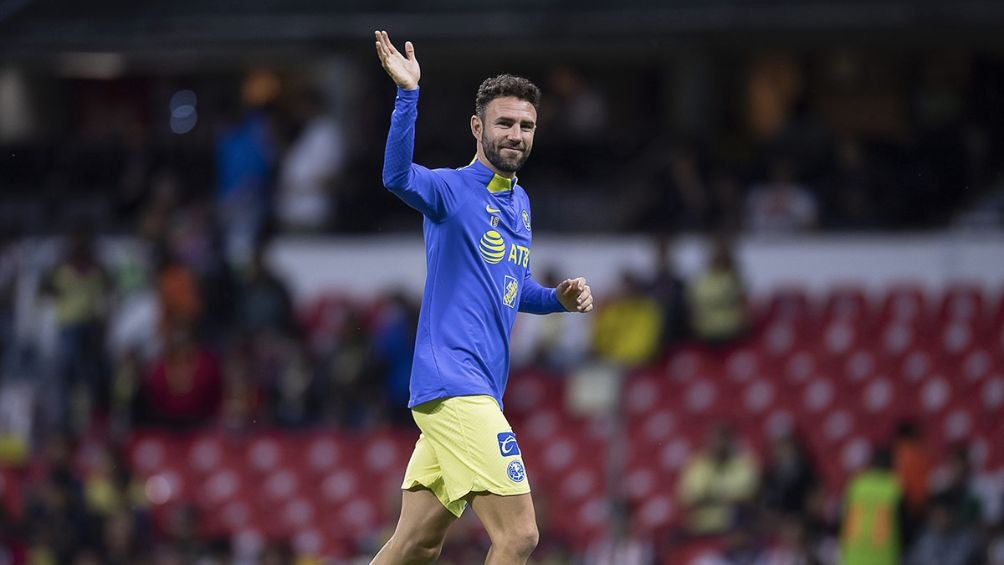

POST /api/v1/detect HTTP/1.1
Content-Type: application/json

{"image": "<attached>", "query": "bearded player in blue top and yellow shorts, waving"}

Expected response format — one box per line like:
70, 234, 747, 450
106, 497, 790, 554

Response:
373, 31, 592, 565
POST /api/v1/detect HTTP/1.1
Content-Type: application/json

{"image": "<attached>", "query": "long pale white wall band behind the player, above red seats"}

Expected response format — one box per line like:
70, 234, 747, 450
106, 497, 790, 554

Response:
271, 233, 1004, 307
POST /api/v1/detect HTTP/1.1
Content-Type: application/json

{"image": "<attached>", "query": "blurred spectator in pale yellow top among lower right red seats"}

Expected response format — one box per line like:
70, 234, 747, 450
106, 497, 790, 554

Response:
677, 425, 759, 535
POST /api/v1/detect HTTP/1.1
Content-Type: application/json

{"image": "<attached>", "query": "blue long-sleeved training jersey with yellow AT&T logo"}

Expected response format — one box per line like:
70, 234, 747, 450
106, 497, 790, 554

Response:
384, 88, 564, 407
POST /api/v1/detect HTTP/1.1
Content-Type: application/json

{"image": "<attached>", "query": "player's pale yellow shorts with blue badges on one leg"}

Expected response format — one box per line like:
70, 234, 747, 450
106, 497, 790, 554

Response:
401, 395, 530, 518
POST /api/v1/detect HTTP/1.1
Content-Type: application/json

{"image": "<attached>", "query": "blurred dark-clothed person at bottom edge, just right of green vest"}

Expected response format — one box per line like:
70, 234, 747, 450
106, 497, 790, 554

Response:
905, 497, 984, 565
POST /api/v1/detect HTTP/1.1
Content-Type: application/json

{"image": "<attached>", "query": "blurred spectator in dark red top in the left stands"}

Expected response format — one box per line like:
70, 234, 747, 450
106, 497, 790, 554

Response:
144, 324, 223, 428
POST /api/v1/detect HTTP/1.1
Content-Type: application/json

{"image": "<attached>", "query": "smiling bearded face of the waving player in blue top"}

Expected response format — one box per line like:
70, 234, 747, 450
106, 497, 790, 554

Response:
474, 96, 537, 174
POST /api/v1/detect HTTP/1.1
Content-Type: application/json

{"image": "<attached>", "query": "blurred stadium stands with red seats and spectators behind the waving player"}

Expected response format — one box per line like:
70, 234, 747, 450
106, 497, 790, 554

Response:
0, 0, 1004, 565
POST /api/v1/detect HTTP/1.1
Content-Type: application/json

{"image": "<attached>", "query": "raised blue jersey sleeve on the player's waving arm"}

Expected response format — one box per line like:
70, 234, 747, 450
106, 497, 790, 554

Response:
384, 87, 459, 222
